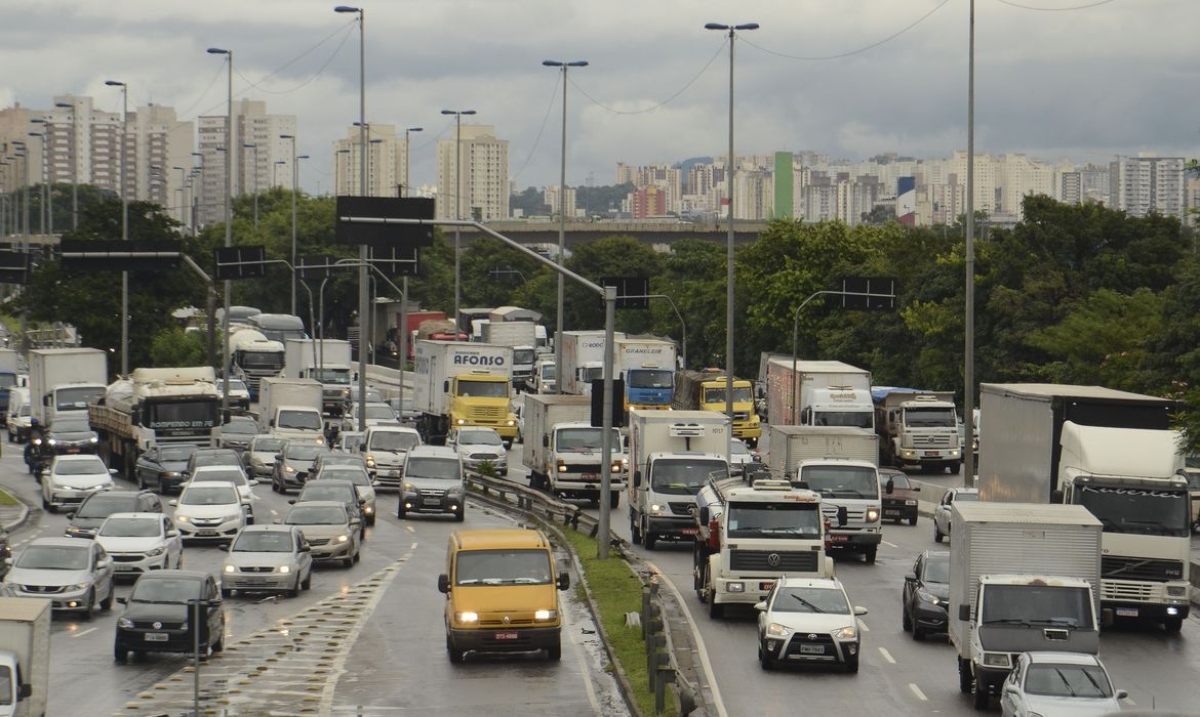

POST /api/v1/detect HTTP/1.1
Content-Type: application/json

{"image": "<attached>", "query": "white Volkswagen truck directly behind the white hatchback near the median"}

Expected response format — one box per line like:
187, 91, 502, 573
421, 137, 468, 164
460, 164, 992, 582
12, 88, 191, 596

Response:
692, 478, 833, 619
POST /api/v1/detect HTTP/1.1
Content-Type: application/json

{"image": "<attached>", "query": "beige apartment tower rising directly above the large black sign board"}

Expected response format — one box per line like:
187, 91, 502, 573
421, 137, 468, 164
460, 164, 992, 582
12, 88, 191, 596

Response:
334, 125, 415, 197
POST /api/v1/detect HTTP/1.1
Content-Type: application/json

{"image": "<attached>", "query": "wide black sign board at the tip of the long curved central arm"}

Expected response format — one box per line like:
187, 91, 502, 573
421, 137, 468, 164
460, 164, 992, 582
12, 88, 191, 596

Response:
335, 197, 433, 248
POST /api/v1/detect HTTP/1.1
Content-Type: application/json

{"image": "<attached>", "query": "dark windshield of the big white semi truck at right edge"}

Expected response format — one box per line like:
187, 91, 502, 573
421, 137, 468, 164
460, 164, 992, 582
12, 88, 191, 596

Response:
1076, 486, 1190, 537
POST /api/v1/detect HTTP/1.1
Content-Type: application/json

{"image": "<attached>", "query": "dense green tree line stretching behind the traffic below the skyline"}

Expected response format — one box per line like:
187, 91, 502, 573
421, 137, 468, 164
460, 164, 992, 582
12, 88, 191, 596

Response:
8, 189, 1200, 453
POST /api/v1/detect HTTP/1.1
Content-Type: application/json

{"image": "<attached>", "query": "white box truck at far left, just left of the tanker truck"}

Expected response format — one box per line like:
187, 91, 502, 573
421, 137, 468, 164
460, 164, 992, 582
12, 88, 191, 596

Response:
29, 348, 108, 426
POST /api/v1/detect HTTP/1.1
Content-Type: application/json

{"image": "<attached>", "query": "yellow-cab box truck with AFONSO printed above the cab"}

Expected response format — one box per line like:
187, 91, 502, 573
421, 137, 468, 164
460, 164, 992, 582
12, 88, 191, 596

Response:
413, 341, 517, 445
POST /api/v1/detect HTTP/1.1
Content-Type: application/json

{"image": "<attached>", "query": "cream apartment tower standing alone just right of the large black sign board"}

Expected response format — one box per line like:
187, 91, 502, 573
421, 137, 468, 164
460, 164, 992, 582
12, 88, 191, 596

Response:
437, 125, 509, 222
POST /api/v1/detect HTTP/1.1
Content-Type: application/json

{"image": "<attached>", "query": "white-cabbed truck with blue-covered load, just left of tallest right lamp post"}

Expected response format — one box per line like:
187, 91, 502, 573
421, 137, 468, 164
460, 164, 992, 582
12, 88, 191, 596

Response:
871, 386, 962, 472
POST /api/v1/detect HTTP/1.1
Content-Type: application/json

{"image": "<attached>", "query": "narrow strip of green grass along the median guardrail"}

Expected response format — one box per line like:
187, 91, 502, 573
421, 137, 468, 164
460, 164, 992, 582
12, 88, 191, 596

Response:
563, 529, 678, 716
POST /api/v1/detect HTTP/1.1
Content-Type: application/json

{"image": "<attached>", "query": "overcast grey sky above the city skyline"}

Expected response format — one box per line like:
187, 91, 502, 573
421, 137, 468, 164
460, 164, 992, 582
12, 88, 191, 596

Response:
0, 0, 1200, 192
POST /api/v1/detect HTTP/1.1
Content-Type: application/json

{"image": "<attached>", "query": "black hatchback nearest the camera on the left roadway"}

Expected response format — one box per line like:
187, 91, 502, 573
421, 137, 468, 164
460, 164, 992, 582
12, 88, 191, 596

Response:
113, 570, 224, 662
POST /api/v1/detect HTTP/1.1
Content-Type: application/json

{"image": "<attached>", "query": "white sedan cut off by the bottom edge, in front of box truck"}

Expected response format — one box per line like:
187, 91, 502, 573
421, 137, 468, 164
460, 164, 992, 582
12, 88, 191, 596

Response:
1000, 652, 1128, 717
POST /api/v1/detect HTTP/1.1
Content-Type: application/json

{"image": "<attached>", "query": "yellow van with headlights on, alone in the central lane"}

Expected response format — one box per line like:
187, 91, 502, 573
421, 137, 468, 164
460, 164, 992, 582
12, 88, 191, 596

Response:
438, 528, 571, 663
